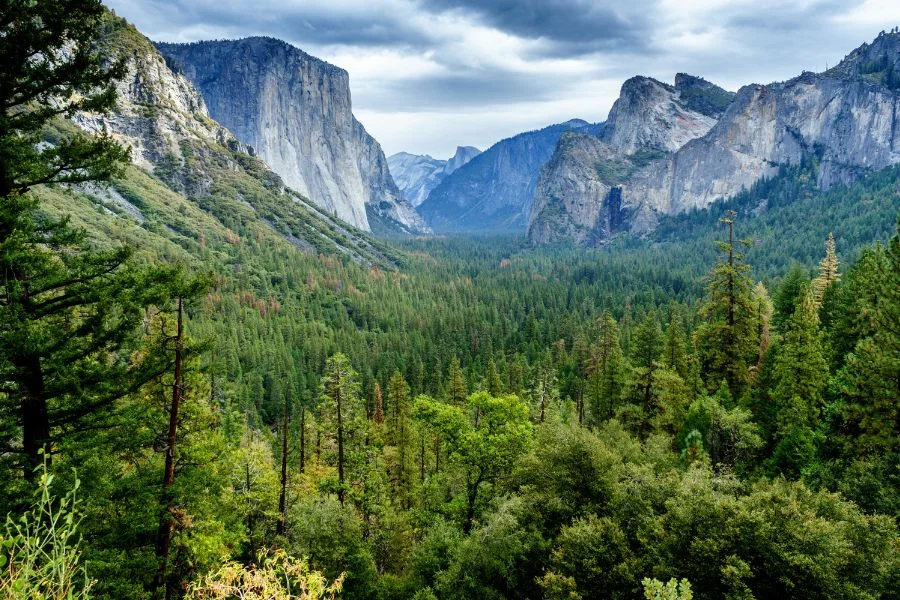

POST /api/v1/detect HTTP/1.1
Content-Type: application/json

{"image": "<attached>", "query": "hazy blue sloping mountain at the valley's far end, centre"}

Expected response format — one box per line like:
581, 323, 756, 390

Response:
418, 119, 602, 232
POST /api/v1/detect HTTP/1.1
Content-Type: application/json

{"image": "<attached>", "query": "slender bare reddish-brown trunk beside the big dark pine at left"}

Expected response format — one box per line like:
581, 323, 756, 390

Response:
156, 298, 184, 598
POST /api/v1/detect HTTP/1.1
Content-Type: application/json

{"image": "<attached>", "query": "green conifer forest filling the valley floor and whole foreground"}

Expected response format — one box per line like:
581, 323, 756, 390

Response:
0, 2, 900, 600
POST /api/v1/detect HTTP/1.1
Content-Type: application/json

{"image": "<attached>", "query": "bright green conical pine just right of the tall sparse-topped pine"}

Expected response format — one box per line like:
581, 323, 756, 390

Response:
772, 289, 828, 475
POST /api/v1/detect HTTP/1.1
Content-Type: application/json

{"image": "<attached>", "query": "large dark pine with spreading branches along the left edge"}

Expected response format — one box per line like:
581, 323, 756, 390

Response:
0, 0, 172, 479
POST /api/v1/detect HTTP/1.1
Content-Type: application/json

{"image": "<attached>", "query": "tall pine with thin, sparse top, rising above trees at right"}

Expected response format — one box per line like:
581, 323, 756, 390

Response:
697, 211, 759, 401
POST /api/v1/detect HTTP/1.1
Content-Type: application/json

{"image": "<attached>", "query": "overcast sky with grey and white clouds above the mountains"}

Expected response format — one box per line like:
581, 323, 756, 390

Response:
106, 0, 900, 158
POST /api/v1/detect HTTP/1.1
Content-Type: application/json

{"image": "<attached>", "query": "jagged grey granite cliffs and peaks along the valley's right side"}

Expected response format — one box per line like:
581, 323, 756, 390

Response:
529, 30, 900, 244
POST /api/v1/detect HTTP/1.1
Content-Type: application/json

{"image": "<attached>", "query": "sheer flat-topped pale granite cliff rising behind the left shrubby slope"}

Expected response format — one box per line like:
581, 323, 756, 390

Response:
157, 38, 426, 232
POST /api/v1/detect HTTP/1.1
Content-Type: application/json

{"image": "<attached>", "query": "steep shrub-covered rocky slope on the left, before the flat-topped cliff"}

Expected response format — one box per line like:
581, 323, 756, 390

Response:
72, 14, 402, 266
